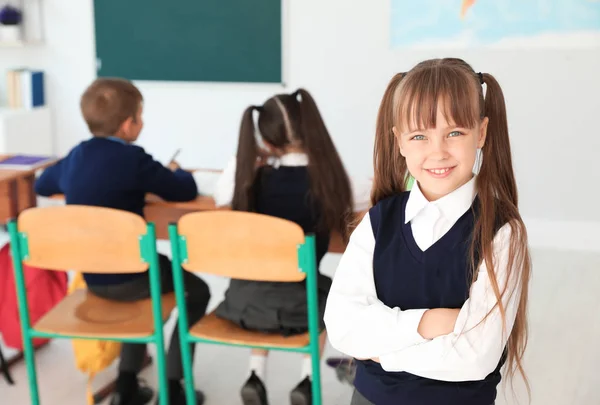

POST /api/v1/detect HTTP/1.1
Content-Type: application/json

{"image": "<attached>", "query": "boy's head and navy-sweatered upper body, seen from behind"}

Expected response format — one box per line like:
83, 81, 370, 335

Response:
35, 79, 197, 285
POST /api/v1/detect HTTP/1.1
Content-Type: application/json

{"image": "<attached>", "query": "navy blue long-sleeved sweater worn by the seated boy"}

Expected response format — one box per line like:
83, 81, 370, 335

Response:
35, 137, 198, 285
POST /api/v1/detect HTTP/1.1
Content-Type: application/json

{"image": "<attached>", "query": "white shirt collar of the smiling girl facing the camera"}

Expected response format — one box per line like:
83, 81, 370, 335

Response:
404, 176, 477, 223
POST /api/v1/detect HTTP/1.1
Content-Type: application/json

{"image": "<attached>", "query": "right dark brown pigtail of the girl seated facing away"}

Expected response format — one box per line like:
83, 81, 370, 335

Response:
292, 89, 354, 240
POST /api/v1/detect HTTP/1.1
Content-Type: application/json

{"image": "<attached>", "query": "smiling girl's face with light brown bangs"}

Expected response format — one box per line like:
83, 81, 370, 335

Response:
392, 59, 489, 201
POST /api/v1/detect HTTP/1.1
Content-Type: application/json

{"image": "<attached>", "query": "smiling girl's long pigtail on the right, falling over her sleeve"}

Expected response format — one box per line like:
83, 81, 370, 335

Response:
471, 73, 531, 398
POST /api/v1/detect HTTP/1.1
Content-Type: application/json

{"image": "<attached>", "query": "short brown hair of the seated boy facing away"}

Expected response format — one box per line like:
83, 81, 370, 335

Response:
80, 78, 143, 137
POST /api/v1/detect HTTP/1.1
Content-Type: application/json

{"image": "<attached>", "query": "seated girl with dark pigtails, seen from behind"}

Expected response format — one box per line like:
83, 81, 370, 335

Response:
215, 89, 354, 405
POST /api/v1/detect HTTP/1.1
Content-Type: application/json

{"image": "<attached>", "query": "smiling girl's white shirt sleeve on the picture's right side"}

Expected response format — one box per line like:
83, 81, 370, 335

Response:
379, 224, 521, 381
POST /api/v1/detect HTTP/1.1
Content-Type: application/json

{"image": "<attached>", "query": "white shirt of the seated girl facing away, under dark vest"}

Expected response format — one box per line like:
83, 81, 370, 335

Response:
213, 153, 372, 211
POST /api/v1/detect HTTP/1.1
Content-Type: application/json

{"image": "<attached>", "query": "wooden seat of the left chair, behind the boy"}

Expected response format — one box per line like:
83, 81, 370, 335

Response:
33, 289, 176, 338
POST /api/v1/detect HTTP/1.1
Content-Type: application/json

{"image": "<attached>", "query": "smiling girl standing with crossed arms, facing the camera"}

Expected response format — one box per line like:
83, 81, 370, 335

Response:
325, 59, 531, 405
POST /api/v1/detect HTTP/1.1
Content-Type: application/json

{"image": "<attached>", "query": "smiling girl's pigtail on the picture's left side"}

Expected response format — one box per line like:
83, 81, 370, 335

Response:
371, 73, 408, 205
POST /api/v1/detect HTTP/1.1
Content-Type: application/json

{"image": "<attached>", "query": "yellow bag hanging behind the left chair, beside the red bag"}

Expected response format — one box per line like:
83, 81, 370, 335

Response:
69, 273, 121, 405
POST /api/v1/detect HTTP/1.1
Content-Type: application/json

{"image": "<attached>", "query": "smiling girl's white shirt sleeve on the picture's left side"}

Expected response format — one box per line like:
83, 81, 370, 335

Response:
325, 214, 426, 359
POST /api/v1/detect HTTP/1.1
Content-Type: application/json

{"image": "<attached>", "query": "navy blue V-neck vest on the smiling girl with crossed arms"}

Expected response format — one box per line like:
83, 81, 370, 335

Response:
355, 192, 504, 405
